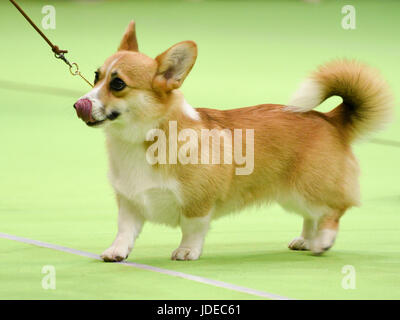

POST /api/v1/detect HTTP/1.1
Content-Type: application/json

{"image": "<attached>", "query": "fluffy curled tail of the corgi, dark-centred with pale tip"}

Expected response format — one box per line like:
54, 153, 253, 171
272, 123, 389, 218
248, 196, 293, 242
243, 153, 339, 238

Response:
288, 60, 393, 141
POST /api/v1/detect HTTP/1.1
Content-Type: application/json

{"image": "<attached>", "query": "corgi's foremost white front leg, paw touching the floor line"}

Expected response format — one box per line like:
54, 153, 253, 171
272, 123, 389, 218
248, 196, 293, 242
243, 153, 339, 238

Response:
101, 196, 144, 262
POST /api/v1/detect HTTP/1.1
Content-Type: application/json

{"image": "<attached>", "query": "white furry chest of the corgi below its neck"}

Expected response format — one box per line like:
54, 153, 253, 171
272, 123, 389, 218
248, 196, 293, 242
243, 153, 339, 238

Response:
109, 139, 181, 226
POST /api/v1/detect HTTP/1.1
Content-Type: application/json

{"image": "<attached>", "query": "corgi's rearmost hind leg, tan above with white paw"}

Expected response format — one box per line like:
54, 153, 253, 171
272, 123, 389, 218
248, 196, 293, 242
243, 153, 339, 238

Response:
310, 209, 345, 255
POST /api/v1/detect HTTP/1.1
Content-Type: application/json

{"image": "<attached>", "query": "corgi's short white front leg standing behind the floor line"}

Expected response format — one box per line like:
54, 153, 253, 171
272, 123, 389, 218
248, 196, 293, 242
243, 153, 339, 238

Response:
171, 214, 211, 260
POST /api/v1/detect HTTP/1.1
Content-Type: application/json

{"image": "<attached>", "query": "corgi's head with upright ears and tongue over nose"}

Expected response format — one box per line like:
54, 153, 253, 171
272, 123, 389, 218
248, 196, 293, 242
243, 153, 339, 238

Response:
74, 21, 197, 126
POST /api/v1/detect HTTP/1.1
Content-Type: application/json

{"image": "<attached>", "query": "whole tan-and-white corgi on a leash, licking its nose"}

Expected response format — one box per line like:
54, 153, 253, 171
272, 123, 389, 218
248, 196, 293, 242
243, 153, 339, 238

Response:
74, 21, 392, 261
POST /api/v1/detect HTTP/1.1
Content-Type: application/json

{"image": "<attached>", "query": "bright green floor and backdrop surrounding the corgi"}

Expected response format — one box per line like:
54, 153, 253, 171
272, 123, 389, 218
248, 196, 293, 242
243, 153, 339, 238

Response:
0, 0, 400, 299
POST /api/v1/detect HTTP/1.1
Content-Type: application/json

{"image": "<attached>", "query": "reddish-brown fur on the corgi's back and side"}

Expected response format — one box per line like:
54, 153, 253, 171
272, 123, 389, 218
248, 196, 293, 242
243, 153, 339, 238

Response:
149, 105, 358, 220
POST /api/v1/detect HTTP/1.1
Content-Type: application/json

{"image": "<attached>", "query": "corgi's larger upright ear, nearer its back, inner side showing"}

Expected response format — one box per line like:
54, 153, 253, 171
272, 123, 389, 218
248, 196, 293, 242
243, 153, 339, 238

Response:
153, 41, 197, 92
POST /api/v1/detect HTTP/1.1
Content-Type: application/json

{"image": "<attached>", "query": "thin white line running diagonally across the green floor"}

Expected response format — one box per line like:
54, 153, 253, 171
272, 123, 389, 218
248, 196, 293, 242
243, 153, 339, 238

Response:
0, 232, 292, 300
